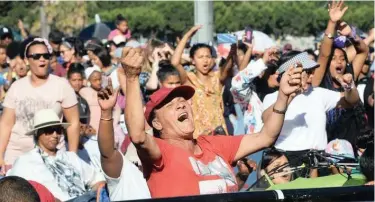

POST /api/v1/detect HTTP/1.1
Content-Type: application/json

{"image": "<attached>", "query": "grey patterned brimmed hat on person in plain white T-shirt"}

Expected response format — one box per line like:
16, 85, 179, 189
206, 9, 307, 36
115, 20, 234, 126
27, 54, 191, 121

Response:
277, 52, 319, 74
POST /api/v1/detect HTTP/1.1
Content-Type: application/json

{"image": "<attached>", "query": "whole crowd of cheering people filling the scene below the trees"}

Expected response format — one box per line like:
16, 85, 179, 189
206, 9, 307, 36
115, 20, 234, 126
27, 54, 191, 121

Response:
0, 1, 375, 201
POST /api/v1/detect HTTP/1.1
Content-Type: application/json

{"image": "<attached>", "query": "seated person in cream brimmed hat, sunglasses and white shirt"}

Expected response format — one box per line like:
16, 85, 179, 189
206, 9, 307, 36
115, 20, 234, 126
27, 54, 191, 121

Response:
7, 109, 104, 201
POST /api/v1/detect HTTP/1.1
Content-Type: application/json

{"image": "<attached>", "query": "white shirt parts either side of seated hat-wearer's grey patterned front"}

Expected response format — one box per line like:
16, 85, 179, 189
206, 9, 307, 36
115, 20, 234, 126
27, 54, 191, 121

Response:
7, 148, 104, 201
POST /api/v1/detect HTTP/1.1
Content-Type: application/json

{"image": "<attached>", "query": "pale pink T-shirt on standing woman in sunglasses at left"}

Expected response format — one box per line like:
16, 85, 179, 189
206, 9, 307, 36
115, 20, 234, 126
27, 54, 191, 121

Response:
3, 74, 78, 164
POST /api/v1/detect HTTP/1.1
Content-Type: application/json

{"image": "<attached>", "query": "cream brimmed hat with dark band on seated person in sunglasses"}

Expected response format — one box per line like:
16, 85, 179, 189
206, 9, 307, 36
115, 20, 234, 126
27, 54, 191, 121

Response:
26, 109, 70, 135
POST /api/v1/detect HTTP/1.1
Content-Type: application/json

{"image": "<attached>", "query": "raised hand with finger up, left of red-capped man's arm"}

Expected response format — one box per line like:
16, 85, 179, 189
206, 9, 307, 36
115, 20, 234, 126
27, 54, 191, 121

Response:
98, 78, 119, 111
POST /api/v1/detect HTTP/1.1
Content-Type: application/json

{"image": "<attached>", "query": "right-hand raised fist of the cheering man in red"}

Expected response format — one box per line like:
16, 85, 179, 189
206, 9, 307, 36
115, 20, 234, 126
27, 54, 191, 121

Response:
279, 64, 303, 96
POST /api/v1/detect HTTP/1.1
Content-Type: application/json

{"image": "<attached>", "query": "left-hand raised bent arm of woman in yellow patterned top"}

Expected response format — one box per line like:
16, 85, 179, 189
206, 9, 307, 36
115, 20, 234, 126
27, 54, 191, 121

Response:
171, 25, 202, 84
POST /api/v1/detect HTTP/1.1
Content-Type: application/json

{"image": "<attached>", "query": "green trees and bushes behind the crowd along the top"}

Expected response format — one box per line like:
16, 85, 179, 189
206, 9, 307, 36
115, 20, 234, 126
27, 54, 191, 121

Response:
0, 1, 374, 38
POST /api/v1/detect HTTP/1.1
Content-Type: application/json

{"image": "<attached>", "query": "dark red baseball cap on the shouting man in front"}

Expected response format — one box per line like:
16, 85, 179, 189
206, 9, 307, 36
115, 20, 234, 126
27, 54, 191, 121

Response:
145, 86, 195, 127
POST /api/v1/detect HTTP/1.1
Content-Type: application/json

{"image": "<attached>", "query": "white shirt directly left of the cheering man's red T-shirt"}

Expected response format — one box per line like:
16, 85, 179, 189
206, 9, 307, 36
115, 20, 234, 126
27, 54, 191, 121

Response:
104, 157, 151, 201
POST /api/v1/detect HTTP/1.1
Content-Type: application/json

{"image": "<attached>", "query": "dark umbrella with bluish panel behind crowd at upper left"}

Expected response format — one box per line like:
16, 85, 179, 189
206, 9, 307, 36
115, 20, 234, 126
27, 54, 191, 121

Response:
78, 22, 115, 41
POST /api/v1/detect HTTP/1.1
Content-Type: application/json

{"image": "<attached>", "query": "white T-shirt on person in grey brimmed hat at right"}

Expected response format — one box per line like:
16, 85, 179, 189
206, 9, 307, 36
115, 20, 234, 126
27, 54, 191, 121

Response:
263, 87, 341, 151
